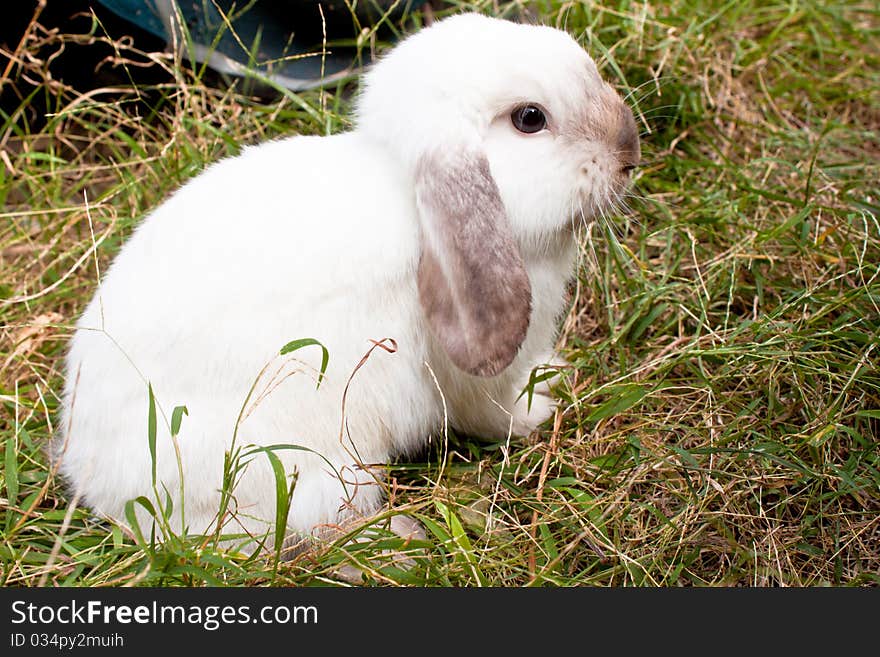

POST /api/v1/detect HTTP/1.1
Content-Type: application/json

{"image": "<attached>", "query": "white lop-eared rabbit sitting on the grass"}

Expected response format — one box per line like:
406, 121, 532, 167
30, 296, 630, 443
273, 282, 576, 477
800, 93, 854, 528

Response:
53, 14, 639, 538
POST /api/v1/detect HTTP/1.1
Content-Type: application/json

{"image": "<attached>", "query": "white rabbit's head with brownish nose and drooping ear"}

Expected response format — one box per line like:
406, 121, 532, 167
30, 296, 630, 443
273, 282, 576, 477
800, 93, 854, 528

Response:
357, 14, 640, 376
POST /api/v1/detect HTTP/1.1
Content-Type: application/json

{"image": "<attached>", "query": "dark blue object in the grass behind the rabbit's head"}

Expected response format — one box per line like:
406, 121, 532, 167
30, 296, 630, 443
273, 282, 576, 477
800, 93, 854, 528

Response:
98, 0, 425, 91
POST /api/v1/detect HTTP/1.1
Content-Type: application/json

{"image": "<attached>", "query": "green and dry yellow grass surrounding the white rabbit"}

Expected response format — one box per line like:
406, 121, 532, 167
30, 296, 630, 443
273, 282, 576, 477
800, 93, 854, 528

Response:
0, 0, 880, 586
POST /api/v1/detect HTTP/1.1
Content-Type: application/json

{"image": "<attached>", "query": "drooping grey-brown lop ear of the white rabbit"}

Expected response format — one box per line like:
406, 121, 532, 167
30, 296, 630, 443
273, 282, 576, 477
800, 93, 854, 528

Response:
416, 152, 532, 376
